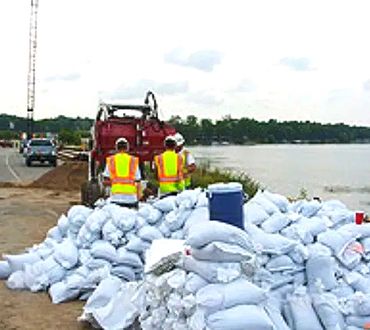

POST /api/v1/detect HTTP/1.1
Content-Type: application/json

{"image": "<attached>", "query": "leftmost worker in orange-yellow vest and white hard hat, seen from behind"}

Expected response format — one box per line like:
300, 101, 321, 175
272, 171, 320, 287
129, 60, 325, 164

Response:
103, 137, 141, 208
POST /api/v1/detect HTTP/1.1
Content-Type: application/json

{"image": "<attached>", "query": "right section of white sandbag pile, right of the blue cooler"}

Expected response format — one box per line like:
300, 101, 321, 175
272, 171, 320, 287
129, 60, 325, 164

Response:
244, 191, 370, 330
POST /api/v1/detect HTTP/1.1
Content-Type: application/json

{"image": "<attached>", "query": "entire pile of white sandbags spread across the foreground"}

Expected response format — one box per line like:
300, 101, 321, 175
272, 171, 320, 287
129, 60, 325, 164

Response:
0, 186, 370, 330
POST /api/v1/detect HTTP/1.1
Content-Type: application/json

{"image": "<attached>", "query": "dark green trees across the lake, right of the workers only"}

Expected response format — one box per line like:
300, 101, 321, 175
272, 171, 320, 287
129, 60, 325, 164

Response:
170, 116, 370, 145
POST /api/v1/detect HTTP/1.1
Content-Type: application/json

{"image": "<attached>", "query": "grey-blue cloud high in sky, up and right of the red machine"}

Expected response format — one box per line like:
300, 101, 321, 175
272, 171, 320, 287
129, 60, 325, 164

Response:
164, 48, 222, 72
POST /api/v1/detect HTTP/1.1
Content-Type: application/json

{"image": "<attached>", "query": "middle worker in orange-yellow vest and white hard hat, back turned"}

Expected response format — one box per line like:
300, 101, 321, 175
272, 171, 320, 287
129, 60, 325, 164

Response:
154, 136, 184, 197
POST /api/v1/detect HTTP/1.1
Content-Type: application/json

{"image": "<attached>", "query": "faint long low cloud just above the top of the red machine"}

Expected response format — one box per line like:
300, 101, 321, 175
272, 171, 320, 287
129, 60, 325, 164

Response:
103, 79, 189, 99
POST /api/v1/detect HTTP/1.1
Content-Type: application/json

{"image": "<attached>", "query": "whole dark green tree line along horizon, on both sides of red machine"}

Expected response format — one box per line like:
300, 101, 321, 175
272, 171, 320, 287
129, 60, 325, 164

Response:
0, 114, 370, 145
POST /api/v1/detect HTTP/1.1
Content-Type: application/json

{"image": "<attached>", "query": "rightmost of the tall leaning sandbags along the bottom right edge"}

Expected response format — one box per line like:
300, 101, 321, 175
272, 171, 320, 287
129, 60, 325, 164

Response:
312, 293, 344, 330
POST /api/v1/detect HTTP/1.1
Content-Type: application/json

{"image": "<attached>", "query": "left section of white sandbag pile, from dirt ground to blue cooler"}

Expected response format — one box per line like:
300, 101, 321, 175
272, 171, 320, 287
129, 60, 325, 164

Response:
0, 189, 208, 303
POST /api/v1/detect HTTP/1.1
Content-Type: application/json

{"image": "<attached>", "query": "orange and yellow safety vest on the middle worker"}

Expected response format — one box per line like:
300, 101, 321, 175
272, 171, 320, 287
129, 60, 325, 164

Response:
155, 150, 184, 193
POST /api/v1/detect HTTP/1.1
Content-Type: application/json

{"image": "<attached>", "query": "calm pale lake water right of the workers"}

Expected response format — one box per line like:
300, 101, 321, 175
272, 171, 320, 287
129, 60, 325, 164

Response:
190, 144, 370, 212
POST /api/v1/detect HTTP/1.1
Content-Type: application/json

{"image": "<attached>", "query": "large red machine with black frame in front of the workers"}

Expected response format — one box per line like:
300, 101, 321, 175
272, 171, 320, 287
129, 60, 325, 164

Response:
81, 91, 176, 205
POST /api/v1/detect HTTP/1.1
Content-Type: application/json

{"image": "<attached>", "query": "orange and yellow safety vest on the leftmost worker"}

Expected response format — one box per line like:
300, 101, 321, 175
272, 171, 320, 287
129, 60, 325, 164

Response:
107, 152, 139, 196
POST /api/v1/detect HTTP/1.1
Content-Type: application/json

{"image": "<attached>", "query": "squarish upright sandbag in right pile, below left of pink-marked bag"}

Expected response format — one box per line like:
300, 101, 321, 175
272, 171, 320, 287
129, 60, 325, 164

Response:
306, 255, 337, 290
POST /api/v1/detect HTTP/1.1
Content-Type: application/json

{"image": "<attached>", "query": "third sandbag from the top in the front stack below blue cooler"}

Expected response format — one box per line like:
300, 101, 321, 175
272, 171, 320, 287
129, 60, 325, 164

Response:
180, 256, 242, 283
